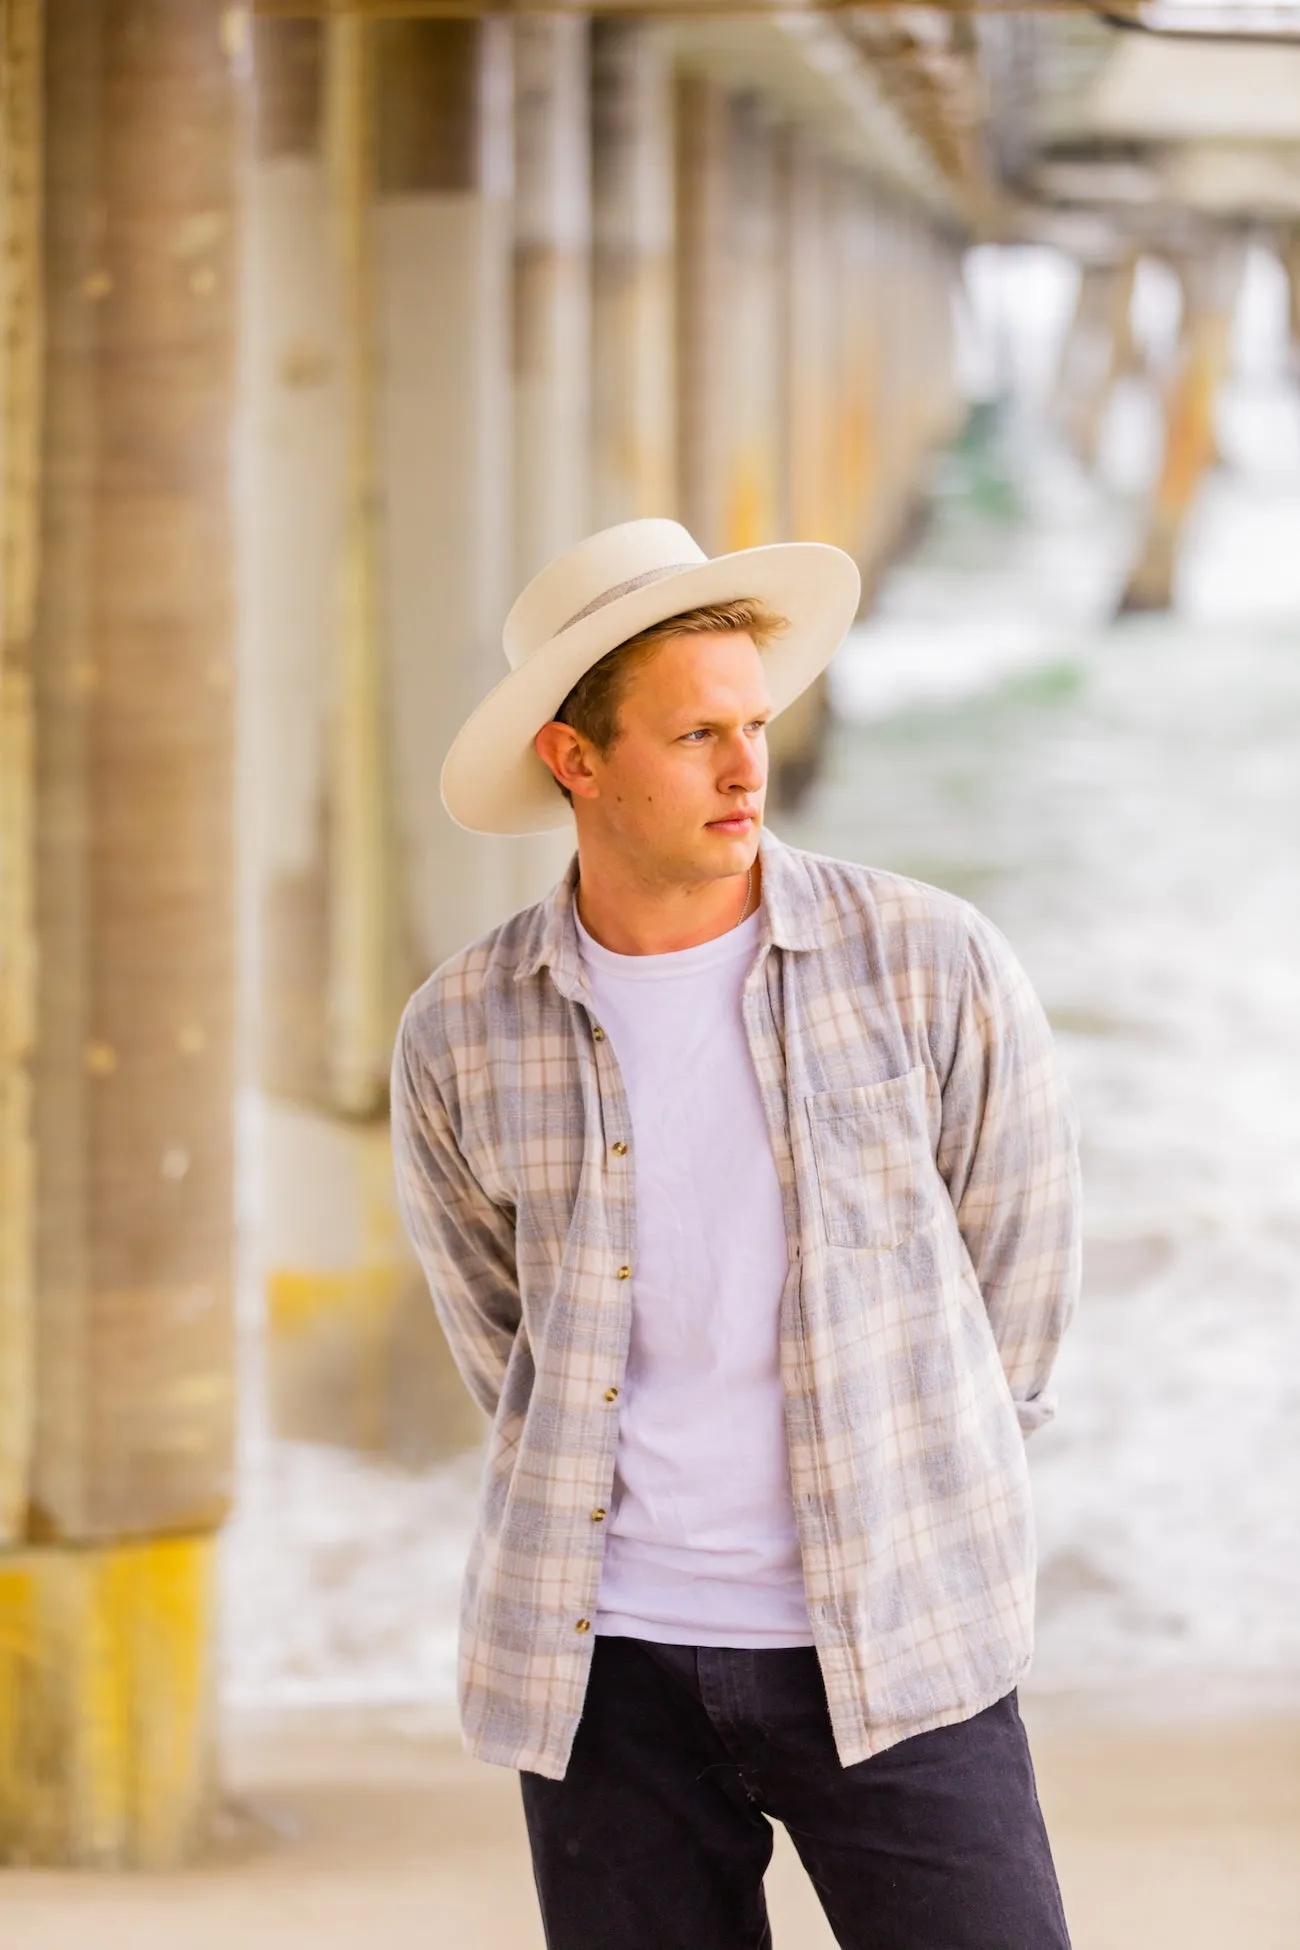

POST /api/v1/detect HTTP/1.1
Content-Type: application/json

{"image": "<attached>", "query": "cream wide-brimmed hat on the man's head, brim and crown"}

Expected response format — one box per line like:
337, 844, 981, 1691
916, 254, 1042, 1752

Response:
442, 521, 861, 833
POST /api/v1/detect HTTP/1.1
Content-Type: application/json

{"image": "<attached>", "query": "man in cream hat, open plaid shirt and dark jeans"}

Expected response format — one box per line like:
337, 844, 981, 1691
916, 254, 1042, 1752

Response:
394, 521, 1078, 1950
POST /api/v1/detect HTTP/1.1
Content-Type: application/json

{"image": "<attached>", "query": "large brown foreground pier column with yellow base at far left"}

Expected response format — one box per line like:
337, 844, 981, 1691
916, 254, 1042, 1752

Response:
0, 0, 244, 1864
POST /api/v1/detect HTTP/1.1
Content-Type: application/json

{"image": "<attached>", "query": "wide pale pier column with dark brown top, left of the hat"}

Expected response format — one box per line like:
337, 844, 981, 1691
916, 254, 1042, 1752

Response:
374, 18, 515, 979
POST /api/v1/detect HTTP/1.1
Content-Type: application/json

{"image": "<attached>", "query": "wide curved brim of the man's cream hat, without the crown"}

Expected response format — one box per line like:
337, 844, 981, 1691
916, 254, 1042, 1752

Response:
442, 542, 861, 835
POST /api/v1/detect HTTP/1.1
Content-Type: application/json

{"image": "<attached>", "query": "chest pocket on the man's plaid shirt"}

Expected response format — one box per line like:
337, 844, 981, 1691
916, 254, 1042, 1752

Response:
805, 1067, 934, 1252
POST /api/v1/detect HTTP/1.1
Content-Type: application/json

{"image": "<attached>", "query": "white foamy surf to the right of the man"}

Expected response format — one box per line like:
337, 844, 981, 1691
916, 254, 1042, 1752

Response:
791, 394, 1300, 1700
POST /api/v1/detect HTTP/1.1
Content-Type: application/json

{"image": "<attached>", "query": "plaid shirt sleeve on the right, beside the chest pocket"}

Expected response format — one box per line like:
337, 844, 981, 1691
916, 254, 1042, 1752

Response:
937, 915, 1080, 1435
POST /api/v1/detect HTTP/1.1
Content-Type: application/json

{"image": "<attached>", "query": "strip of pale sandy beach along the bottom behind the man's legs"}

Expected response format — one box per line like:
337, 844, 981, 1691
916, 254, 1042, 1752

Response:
0, 1702, 1300, 1950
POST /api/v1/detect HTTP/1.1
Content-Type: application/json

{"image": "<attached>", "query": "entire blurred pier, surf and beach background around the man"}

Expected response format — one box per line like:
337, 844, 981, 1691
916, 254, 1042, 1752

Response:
0, 0, 1300, 1950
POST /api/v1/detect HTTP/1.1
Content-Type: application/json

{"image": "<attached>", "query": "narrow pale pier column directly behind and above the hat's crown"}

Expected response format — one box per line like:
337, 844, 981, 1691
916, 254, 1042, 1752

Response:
509, 14, 591, 907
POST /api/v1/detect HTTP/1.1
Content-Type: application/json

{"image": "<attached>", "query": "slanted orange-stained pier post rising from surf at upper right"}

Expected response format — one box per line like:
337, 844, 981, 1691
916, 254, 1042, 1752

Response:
1121, 240, 1245, 612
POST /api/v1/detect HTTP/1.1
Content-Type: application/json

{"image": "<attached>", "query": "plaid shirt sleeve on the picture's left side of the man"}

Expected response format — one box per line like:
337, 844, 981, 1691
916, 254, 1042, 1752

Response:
392, 1016, 520, 1416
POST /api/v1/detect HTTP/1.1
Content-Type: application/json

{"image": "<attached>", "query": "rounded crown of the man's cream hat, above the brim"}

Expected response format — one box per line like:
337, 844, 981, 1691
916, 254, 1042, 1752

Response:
505, 517, 707, 671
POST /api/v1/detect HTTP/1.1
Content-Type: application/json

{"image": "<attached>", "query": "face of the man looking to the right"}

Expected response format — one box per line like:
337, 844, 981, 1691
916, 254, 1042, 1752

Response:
579, 630, 772, 885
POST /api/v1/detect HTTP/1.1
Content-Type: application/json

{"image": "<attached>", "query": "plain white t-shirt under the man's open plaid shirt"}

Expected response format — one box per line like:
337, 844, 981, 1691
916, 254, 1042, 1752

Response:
579, 897, 813, 1646
